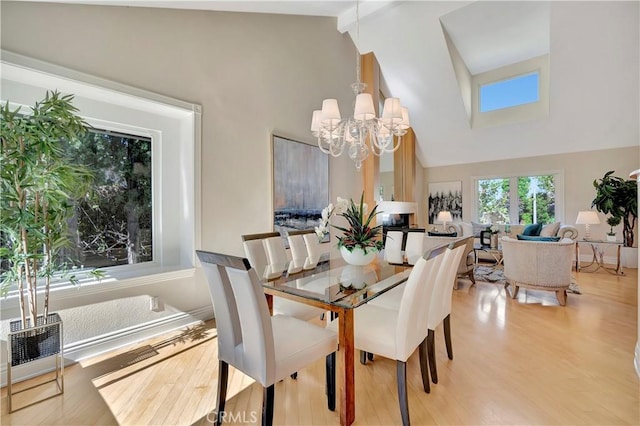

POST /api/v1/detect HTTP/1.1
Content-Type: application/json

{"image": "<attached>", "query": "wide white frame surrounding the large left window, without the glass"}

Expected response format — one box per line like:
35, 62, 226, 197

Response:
0, 51, 201, 300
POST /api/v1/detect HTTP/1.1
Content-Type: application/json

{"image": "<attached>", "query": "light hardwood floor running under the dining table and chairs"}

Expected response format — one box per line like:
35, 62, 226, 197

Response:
2, 269, 640, 425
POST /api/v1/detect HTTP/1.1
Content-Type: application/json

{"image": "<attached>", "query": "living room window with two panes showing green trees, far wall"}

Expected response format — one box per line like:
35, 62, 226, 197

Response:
476, 173, 560, 225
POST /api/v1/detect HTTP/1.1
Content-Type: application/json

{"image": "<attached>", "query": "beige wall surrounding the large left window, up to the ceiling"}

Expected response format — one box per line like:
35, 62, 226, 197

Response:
1, 1, 362, 380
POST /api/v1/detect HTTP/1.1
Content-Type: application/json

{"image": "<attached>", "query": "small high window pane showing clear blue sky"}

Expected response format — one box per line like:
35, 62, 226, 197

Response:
480, 72, 540, 112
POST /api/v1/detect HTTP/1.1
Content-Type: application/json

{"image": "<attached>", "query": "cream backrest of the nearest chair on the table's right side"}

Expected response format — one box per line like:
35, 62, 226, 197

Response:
396, 246, 451, 361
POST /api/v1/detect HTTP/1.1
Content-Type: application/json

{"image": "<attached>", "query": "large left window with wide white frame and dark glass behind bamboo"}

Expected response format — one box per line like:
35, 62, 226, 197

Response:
0, 52, 200, 297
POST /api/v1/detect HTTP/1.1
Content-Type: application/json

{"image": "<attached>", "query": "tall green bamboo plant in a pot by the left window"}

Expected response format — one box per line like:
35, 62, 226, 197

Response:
0, 92, 92, 372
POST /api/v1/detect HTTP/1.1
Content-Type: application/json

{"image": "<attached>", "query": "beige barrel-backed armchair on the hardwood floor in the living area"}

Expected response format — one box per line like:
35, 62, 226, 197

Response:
502, 237, 575, 306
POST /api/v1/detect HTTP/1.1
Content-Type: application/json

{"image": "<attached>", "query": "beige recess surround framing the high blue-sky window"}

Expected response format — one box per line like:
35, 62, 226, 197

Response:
471, 55, 549, 128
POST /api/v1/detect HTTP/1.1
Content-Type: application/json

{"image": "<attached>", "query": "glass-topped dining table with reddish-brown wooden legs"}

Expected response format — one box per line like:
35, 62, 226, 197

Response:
262, 256, 411, 425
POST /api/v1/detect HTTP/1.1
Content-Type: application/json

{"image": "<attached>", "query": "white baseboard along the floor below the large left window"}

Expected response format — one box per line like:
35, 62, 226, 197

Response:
0, 305, 211, 386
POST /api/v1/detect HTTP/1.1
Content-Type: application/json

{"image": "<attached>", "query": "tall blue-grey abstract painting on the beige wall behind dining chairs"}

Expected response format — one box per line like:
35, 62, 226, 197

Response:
272, 135, 329, 245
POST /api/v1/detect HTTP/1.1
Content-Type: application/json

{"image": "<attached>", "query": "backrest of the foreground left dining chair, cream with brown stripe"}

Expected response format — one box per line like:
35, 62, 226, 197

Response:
196, 250, 275, 386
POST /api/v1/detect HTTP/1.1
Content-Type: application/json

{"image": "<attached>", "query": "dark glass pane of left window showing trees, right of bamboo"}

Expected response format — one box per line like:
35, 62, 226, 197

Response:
71, 129, 153, 268
